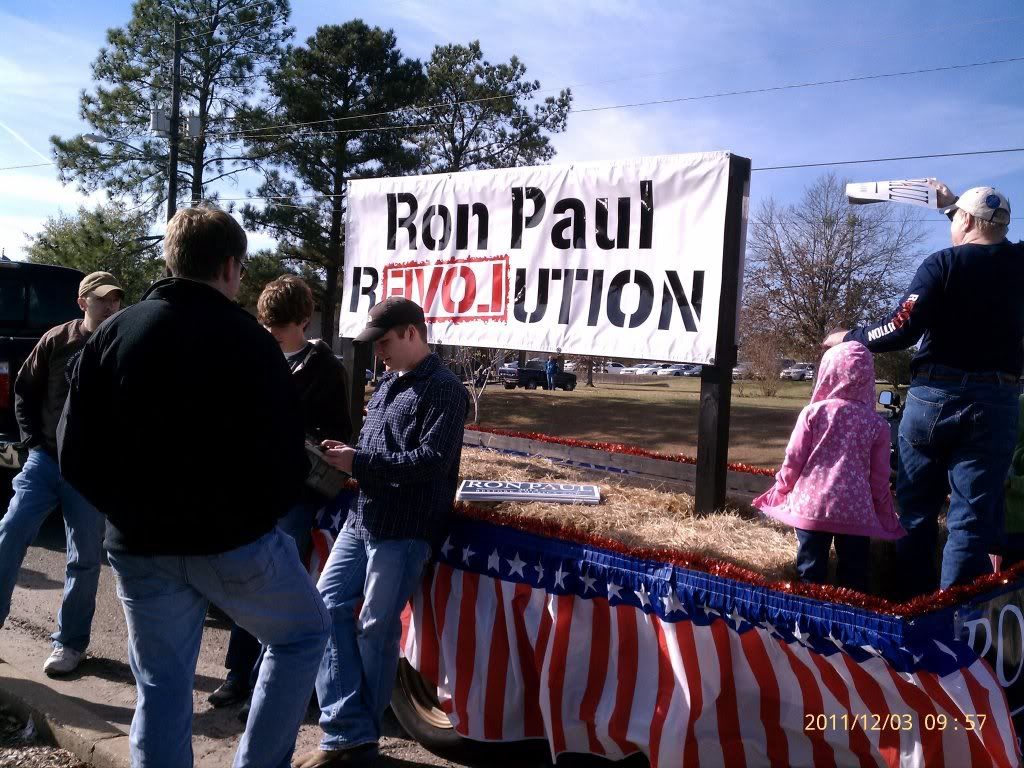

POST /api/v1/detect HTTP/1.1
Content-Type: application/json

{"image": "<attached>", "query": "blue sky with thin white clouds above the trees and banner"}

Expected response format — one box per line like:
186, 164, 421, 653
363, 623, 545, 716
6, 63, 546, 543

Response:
0, 0, 1024, 257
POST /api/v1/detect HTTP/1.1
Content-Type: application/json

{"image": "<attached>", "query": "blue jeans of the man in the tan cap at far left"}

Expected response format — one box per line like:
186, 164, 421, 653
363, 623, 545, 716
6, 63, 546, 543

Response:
0, 450, 103, 651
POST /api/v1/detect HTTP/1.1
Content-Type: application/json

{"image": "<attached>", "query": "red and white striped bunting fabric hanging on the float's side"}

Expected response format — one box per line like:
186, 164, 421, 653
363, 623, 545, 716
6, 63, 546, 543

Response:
403, 561, 1019, 768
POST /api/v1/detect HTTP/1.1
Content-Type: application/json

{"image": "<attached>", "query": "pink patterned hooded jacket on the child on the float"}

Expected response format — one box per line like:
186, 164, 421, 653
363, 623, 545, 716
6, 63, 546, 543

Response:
754, 341, 906, 539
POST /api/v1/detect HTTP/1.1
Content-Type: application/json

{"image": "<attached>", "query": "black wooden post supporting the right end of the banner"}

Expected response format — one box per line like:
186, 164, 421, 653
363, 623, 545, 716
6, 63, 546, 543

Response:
695, 155, 751, 514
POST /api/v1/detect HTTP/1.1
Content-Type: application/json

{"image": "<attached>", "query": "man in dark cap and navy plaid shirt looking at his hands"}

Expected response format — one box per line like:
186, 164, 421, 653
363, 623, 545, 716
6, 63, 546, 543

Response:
293, 297, 469, 768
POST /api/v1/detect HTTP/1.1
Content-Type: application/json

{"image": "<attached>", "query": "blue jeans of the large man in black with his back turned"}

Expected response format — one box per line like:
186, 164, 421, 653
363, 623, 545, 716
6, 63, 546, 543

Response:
109, 528, 331, 768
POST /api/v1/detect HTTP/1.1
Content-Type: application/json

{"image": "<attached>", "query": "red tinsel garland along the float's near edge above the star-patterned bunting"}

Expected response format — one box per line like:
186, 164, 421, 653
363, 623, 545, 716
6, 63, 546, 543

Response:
337, 477, 1024, 618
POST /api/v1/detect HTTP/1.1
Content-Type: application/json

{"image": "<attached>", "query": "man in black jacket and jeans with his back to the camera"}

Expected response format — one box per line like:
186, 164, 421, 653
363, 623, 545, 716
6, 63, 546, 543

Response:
60, 208, 330, 766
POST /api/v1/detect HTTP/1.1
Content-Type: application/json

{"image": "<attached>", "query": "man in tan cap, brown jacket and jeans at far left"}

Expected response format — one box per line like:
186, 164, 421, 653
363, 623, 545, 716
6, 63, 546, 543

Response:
0, 272, 124, 676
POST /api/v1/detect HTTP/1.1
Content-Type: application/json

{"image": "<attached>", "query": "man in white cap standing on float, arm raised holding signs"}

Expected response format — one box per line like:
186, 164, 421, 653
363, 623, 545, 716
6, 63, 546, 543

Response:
824, 184, 1024, 596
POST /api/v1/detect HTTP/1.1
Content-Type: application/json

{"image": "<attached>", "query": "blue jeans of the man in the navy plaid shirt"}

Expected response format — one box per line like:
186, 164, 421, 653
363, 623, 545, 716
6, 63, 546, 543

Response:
316, 528, 430, 750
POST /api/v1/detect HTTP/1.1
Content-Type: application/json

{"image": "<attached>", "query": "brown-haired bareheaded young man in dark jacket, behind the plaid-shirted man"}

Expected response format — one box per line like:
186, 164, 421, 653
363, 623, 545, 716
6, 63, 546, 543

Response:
209, 274, 352, 716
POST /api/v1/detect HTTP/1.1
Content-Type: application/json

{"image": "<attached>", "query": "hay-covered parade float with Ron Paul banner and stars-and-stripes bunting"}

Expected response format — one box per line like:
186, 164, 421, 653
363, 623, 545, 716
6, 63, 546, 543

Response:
329, 153, 1024, 766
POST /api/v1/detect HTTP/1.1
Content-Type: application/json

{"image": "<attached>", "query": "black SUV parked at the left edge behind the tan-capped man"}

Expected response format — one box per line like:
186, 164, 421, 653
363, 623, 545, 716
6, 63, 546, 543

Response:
0, 258, 85, 475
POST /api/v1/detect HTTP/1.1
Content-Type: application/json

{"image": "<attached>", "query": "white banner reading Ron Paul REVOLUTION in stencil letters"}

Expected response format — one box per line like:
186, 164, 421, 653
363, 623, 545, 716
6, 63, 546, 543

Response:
340, 153, 745, 362
